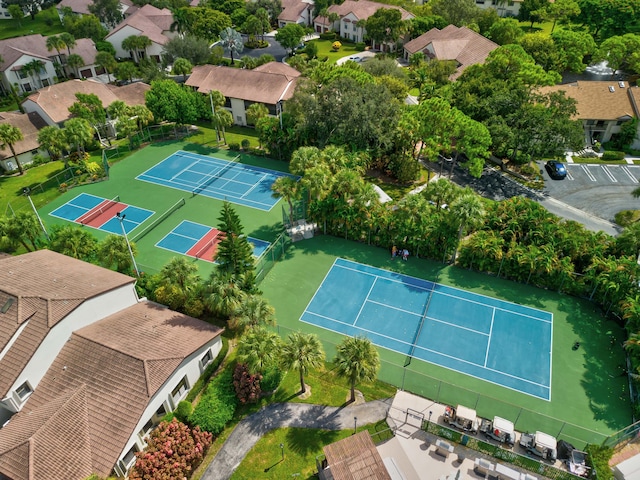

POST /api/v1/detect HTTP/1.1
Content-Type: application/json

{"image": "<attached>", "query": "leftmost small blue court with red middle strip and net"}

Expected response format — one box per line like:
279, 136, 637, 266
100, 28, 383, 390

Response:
49, 193, 155, 235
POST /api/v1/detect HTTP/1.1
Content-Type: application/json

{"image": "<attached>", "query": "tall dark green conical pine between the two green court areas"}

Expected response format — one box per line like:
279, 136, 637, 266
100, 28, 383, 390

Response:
216, 202, 257, 293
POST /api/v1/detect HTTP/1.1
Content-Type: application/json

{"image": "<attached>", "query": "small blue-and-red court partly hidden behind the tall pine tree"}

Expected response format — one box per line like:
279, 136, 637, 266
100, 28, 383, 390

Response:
156, 220, 271, 262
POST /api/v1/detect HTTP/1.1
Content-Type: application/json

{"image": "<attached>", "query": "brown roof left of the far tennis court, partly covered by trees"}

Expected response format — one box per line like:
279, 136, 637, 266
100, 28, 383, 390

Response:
23, 79, 151, 123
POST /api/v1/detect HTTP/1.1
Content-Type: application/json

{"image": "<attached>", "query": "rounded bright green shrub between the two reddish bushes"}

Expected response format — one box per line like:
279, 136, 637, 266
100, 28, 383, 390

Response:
189, 370, 238, 435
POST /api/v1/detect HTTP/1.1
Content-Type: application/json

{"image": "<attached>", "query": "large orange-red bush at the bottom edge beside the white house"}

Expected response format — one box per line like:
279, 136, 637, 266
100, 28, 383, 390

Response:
129, 418, 211, 480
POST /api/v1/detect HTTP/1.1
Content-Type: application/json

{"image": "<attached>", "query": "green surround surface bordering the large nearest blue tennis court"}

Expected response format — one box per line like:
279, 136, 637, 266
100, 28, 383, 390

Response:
260, 236, 631, 447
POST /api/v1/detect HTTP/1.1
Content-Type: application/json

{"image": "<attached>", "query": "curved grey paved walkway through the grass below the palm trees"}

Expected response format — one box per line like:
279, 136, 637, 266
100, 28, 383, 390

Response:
201, 399, 393, 480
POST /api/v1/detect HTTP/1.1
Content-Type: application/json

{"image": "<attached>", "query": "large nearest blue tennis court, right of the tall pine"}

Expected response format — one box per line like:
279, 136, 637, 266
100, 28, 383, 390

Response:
300, 258, 553, 400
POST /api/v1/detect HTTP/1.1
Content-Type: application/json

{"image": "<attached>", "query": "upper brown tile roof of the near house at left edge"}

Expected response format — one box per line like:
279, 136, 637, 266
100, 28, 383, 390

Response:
0, 250, 135, 397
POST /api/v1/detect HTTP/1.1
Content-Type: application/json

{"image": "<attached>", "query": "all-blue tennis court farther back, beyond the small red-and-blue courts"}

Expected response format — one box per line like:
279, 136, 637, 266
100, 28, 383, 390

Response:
136, 150, 297, 211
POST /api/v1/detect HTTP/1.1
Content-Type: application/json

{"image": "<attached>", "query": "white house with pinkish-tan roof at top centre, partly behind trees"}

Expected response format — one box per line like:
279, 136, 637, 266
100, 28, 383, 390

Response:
313, 0, 415, 51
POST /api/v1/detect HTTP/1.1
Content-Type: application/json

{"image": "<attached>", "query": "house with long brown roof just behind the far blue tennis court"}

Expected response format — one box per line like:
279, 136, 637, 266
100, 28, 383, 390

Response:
185, 62, 300, 125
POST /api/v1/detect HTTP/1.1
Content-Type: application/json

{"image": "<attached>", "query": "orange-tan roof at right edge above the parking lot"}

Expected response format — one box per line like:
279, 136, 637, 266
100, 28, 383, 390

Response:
540, 81, 640, 120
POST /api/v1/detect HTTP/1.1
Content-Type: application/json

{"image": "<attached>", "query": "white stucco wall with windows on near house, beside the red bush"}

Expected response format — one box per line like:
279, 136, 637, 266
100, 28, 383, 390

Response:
116, 335, 222, 474
